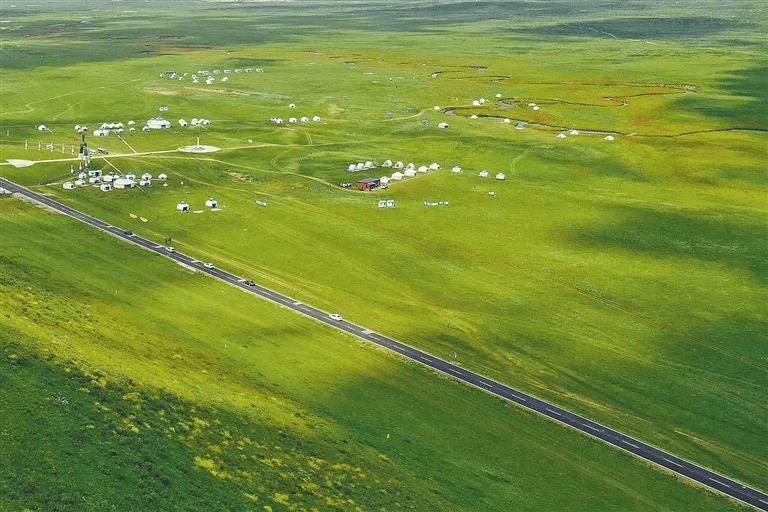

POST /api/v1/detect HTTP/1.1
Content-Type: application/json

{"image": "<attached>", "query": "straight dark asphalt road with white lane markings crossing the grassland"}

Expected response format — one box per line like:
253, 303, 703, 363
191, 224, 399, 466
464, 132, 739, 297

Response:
0, 178, 768, 511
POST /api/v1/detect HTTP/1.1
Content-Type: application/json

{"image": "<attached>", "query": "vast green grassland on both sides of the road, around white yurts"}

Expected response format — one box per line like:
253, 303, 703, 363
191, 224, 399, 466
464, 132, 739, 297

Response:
0, 2, 768, 510
